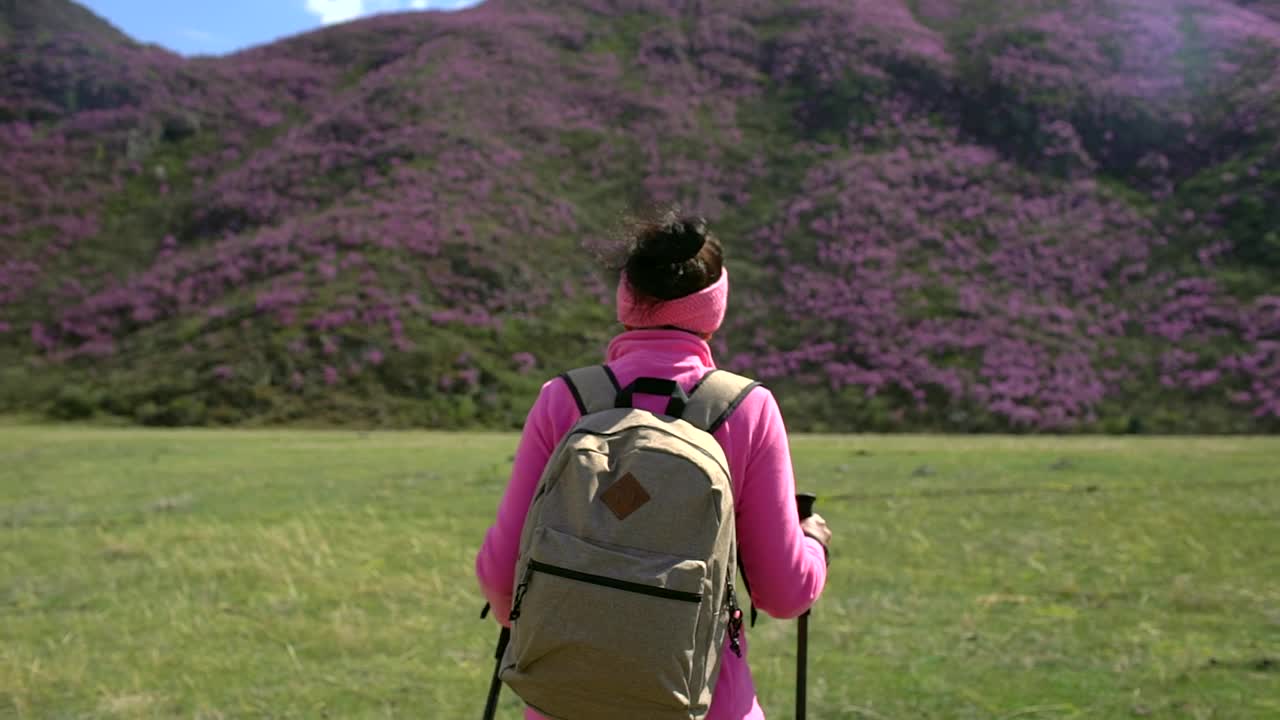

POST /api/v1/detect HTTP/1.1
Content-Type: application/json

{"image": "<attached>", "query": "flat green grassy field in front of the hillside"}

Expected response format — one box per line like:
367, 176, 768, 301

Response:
0, 424, 1280, 719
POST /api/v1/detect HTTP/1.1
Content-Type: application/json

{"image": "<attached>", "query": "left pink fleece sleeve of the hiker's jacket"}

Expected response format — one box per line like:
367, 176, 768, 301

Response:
476, 379, 577, 625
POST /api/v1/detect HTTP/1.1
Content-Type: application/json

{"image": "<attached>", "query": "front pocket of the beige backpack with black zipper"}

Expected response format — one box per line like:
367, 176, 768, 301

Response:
503, 527, 710, 716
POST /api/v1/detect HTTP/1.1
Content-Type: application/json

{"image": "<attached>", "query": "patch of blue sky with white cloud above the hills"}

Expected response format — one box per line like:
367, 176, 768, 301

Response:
81, 0, 479, 55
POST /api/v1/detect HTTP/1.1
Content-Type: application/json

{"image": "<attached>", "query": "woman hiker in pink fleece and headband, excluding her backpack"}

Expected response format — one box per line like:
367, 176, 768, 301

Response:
476, 214, 831, 720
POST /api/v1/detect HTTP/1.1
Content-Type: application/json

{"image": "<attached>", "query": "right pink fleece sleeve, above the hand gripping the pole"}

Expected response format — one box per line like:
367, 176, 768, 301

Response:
735, 389, 827, 619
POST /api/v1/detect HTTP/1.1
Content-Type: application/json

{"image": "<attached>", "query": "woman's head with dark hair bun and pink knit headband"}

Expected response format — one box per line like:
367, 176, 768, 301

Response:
618, 213, 728, 337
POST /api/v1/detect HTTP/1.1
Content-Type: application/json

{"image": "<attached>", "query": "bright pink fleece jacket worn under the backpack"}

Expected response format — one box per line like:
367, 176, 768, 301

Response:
476, 329, 827, 720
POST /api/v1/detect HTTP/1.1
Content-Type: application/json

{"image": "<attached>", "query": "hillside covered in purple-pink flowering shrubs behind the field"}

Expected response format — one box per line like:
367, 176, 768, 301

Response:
0, 0, 1280, 432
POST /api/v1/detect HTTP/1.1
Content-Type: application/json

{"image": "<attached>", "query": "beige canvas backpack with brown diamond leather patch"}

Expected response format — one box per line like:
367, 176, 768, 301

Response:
499, 366, 759, 720
